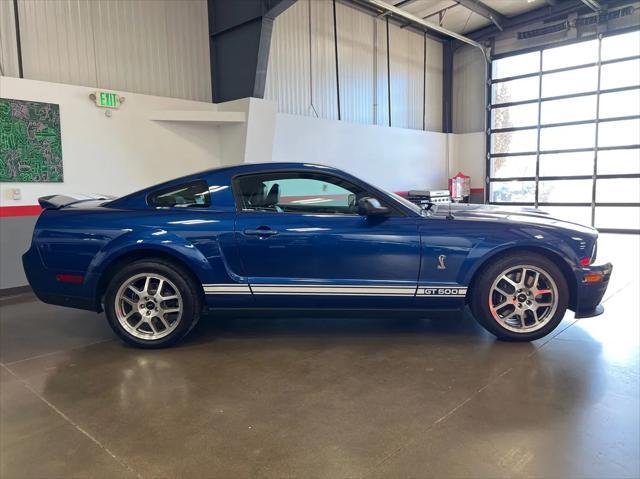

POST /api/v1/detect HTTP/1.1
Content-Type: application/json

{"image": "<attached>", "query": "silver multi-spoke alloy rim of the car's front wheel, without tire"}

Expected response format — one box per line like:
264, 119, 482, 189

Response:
489, 265, 558, 333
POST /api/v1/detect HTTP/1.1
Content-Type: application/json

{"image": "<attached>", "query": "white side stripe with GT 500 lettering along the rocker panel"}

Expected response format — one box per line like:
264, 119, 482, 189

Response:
202, 283, 467, 298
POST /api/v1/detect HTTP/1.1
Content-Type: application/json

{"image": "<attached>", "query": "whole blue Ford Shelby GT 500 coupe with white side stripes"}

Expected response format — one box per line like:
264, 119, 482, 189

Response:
23, 163, 612, 347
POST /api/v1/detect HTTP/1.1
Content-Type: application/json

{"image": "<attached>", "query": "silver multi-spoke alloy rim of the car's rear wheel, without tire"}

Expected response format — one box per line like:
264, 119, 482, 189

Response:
115, 273, 183, 341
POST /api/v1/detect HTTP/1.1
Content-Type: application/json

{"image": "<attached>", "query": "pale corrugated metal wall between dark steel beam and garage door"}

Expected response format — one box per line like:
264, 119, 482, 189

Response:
265, 0, 442, 131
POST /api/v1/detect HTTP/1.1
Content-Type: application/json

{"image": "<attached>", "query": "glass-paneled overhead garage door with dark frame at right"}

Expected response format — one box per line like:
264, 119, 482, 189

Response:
487, 30, 640, 233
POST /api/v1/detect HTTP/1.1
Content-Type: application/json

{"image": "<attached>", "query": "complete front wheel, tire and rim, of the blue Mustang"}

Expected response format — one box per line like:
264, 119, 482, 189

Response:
470, 253, 569, 341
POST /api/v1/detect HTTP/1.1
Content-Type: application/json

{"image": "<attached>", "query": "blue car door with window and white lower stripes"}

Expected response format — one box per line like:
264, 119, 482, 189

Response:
234, 171, 420, 308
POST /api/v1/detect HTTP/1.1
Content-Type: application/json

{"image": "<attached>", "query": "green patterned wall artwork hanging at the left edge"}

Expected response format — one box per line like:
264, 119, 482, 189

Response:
0, 98, 63, 183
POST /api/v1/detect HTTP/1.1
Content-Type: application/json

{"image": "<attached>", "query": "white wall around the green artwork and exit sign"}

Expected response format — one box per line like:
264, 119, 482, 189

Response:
0, 77, 225, 206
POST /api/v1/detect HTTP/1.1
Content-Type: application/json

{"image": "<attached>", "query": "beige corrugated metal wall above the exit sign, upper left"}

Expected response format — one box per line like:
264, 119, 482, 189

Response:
0, 0, 211, 101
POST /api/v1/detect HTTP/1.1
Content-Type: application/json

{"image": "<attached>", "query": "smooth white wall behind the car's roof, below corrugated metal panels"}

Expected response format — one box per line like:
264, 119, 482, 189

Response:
271, 113, 447, 191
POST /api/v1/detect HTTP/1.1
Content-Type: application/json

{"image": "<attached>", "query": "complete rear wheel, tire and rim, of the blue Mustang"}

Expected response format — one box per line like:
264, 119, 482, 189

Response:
105, 259, 201, 348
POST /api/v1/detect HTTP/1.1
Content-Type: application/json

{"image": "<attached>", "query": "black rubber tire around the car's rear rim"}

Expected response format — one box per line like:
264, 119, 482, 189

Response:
104, 258, 202, 349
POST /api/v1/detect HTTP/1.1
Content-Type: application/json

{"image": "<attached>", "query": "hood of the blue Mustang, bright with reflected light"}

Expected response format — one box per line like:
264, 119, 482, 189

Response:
431, 203, 597, 234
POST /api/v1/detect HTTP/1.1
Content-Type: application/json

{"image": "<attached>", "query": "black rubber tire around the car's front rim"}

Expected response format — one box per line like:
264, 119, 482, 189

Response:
469, 251, 569, 341
